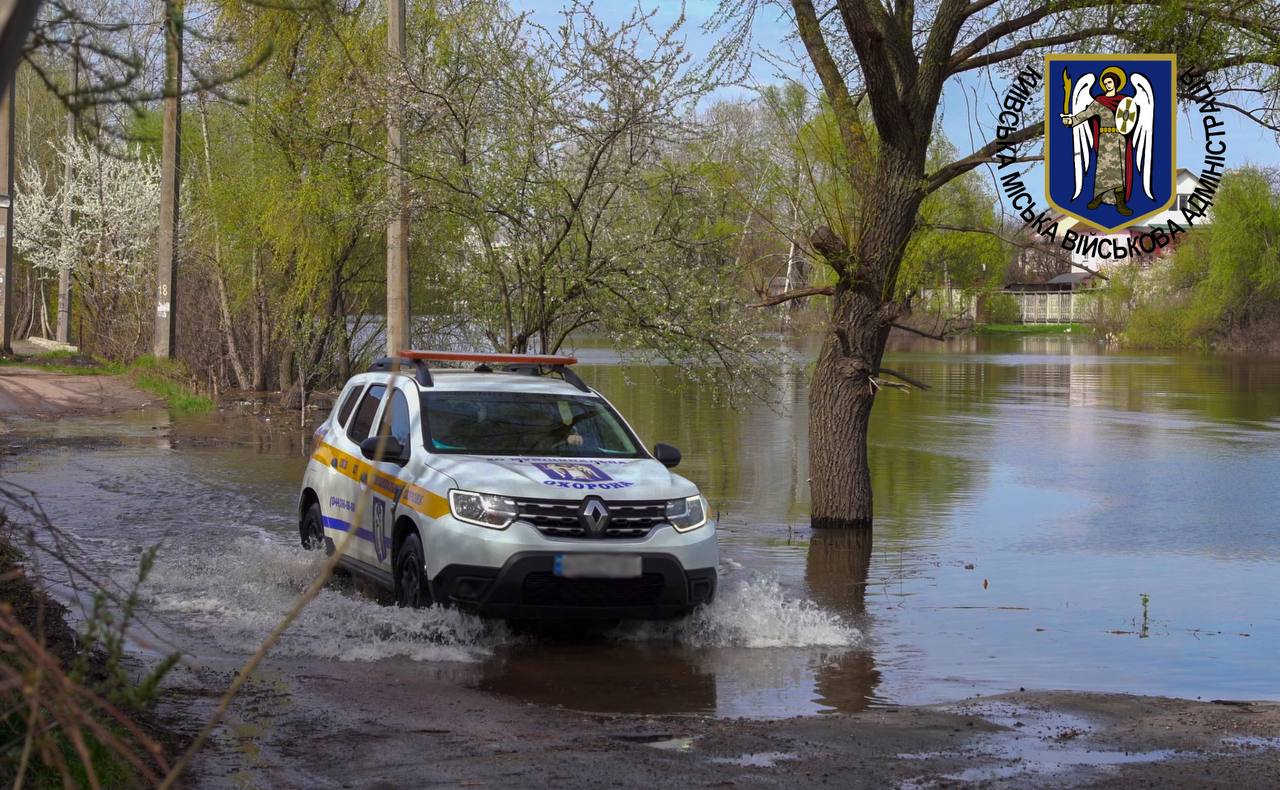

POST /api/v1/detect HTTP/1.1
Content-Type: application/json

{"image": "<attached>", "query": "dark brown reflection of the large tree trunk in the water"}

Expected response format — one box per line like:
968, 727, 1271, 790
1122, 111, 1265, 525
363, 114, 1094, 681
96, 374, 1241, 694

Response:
804, 529, 879, 713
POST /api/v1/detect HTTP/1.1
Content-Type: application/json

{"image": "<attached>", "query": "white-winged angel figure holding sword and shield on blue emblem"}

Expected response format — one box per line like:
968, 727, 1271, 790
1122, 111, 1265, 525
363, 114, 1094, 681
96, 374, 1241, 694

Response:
1060, 65, 1156, 216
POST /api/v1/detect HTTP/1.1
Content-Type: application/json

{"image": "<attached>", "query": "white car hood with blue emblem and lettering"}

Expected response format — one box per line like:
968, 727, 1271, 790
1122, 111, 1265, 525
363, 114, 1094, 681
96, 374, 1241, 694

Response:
430, 455, 698, 501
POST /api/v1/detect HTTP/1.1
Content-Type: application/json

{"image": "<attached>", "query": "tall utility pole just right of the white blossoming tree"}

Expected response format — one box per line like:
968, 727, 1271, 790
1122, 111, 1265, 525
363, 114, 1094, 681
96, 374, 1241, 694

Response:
152, 0, 183, 360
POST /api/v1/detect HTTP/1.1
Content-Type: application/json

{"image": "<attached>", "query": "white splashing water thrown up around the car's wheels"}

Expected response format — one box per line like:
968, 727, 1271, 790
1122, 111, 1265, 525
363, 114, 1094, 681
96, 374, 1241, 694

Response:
145, 538, 861, 662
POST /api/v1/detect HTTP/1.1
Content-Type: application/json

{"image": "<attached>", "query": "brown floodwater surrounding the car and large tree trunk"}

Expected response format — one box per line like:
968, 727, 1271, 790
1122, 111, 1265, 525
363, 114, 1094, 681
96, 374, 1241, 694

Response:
4, 337, 1280, 717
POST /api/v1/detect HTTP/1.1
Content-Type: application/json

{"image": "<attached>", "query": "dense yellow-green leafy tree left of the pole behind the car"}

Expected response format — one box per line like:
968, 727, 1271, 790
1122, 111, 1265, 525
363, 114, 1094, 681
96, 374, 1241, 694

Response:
192, 5, 387, 389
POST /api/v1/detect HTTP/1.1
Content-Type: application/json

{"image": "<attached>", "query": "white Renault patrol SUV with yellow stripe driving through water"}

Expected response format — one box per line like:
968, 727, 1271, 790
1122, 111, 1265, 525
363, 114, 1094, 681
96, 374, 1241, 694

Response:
300, 351, 718, 620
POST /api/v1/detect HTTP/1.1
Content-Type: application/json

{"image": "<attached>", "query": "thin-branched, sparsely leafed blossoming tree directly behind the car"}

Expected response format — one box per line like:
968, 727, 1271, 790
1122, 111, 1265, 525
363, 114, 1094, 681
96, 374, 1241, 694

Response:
407, 3, 767, 388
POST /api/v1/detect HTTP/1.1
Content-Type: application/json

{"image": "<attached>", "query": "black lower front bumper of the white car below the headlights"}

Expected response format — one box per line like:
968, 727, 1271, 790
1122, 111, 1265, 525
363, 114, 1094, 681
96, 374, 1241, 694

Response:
430, 551, 716, 620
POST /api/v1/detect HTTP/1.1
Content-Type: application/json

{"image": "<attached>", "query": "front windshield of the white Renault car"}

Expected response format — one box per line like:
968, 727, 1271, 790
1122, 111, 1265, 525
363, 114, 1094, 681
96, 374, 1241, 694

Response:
422, 392, 641, 458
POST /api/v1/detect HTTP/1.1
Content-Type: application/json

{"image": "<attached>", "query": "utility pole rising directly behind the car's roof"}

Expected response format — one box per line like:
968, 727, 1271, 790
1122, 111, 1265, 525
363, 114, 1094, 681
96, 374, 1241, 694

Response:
387, 0, 410, 356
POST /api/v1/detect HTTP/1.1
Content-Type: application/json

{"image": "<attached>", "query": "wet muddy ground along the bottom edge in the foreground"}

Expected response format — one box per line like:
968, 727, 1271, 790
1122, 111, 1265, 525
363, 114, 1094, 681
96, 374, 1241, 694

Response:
152, 659, 1280, 789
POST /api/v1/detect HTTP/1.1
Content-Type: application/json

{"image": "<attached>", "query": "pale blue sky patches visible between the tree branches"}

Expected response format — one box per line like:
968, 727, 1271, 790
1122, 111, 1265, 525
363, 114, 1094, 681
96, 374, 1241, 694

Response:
516, 0, 1280, 212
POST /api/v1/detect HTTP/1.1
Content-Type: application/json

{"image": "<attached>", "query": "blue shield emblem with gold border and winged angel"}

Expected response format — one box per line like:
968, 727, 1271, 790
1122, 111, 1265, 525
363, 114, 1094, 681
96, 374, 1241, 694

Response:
1044, 55, 1178, 232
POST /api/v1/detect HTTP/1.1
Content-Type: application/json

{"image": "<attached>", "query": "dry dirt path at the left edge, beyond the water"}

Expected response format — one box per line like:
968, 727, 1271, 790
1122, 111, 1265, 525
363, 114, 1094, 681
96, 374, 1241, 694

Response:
0, 366, 156, 421
